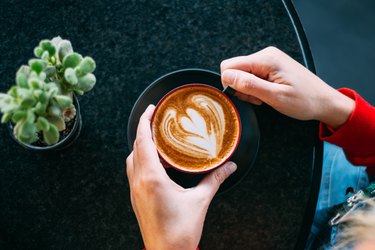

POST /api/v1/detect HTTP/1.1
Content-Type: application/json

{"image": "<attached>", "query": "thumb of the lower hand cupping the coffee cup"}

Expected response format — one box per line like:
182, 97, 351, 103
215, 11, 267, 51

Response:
195, 161, 237, 201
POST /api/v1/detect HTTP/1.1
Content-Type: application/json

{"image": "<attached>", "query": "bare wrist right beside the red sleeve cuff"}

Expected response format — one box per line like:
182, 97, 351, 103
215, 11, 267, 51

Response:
319, 89, 355, 130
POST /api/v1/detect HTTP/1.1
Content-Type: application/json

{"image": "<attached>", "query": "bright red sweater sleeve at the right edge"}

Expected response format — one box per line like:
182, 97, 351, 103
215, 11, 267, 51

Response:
319, 88, 375, 175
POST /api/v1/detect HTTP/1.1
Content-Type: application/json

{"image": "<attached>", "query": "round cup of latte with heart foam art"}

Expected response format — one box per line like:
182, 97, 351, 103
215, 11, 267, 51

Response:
152, 84, 241, 172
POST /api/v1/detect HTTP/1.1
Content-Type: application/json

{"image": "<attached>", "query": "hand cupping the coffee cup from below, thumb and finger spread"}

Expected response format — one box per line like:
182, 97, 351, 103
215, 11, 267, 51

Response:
126, 105, 237, 250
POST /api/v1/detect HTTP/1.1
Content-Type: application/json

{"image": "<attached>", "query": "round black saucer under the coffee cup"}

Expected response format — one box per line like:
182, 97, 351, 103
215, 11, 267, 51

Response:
128, 69, 260, 193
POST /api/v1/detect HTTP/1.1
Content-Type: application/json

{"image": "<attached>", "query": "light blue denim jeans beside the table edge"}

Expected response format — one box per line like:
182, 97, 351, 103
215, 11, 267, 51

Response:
305, 142, 369, 249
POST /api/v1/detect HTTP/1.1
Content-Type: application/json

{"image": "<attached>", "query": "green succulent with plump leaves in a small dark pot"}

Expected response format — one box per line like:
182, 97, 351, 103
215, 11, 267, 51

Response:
0, 37, 96, 145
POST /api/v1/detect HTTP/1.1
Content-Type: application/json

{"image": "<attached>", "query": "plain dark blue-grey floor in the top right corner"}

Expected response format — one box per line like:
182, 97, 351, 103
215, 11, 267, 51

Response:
293, 0, 375, 105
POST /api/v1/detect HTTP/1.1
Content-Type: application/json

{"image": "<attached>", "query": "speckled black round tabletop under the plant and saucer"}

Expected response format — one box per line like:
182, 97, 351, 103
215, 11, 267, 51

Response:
0, 0, 321, 250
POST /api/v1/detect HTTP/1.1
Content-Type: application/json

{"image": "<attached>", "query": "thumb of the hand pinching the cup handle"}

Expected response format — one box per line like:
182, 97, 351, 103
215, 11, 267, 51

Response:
221, 69, 284, 102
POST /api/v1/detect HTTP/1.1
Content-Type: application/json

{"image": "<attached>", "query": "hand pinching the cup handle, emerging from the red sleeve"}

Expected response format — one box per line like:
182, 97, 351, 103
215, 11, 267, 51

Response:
221, 47, 355, 129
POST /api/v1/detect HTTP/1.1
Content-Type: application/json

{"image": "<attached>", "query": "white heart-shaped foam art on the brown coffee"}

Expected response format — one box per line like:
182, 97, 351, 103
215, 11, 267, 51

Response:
161, 94, 225, 159
